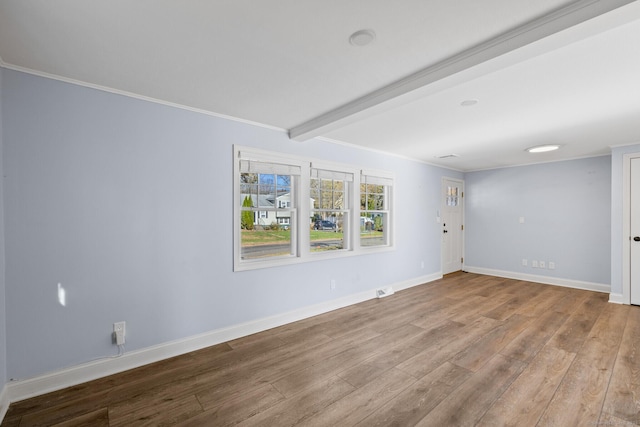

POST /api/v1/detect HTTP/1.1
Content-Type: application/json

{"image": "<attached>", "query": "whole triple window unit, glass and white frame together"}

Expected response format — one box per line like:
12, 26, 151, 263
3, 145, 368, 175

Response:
233, 146, 393, 271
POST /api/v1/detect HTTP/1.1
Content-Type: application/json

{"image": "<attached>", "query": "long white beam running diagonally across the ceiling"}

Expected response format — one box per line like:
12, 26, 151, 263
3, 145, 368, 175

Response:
289, 0, 636, 142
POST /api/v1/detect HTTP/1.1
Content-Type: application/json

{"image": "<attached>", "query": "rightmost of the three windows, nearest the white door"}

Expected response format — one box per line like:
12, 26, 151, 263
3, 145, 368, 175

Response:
360, 171, 393, 247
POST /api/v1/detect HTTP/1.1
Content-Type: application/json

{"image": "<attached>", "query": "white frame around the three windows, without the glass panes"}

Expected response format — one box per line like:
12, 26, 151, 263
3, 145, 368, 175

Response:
233, 145, 395, 271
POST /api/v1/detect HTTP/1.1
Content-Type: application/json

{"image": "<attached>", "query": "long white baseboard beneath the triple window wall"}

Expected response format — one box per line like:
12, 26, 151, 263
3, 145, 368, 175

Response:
6, 273, 442, 406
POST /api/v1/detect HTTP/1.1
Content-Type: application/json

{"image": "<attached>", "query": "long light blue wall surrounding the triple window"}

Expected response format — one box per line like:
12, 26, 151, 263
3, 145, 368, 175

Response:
3, 70, 462, 379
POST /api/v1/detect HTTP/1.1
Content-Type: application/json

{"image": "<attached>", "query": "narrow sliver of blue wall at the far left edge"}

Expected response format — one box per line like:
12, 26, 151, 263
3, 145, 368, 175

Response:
0, 68, 7, 391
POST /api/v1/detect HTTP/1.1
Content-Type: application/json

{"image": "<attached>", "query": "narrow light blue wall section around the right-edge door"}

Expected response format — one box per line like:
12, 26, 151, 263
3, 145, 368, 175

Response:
611, 144, 640, 294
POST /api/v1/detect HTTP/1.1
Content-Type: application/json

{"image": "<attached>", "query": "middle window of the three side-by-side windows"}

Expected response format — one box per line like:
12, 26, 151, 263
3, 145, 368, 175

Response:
309, 168, 353, 252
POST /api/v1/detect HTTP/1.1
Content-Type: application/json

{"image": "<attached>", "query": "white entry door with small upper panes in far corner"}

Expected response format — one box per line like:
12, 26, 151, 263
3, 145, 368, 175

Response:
440, 178, 463, 274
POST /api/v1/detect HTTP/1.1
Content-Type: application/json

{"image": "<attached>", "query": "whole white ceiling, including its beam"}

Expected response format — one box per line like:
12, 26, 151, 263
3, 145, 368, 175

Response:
0, 0, 640, 171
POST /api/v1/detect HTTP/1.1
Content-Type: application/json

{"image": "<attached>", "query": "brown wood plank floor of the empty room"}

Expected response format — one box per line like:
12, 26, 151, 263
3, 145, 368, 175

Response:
2, 273, 640, 427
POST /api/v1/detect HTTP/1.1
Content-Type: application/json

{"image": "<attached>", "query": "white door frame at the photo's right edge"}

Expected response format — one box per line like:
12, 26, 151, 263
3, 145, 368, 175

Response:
622, 153, 640, 305
